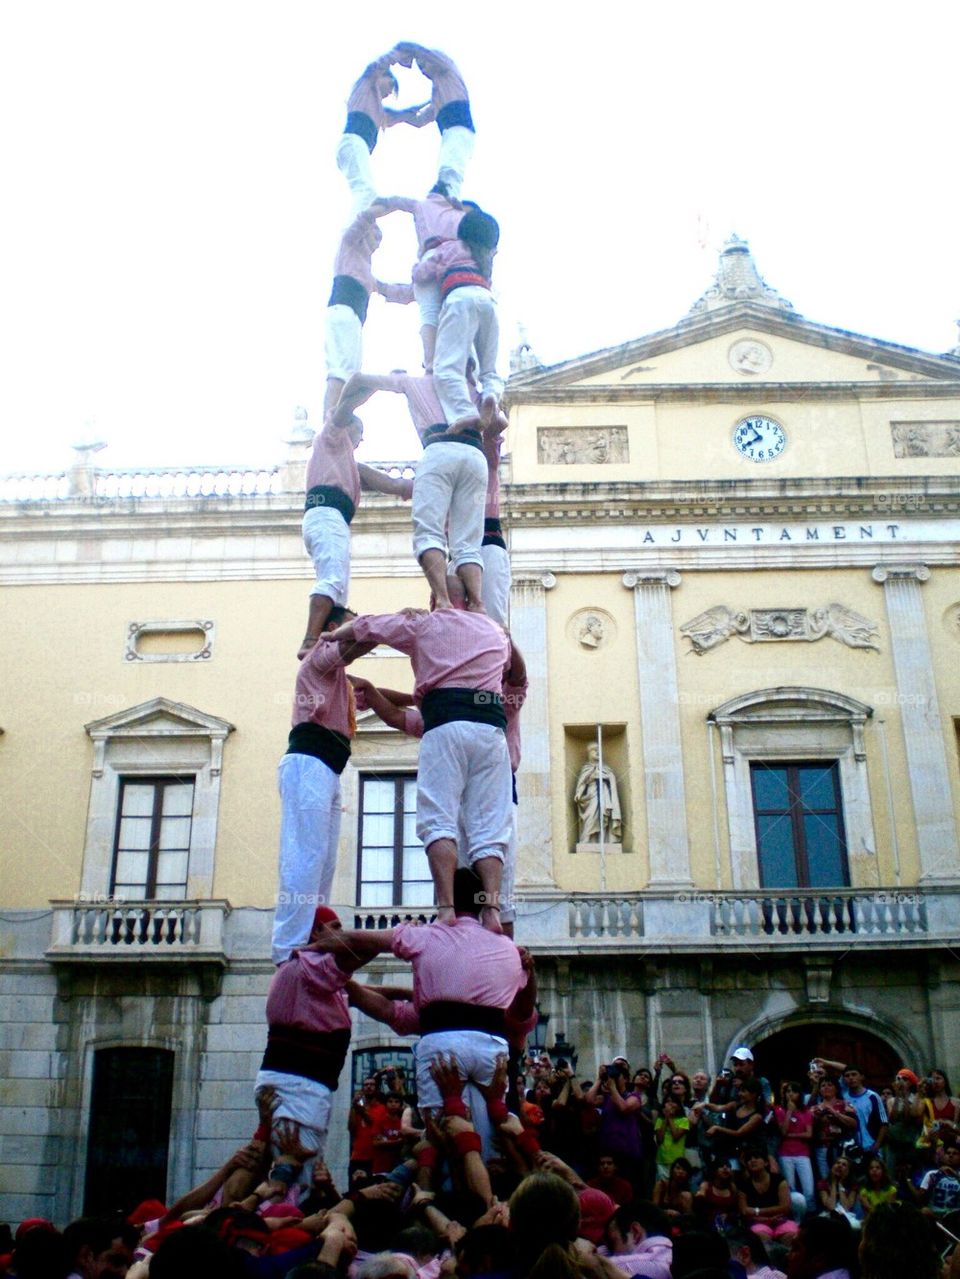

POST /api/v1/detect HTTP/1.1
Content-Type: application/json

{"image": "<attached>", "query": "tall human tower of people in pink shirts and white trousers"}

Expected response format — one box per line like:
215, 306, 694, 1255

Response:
257, 43, 533, 1177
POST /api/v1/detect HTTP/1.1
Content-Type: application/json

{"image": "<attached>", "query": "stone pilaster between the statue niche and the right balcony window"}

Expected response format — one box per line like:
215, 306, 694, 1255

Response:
623, 569, 693, 889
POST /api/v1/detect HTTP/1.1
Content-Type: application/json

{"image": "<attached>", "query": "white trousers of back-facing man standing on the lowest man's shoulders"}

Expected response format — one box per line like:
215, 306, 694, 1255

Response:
417, 721, 513, 866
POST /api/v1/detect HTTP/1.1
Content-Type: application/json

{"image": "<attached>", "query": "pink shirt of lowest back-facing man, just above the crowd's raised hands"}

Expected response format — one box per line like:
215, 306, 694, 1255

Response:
392, 914, 527, 1010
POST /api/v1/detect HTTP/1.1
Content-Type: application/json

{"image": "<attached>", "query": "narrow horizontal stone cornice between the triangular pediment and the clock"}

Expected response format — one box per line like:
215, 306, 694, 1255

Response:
504, 379, 960, 407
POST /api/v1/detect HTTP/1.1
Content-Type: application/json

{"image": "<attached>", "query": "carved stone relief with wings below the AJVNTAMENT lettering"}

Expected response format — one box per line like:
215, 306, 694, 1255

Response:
680, 604, 879, 656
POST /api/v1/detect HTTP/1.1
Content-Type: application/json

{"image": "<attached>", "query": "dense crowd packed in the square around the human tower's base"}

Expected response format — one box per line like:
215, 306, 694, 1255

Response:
0, 1046, 960, 1279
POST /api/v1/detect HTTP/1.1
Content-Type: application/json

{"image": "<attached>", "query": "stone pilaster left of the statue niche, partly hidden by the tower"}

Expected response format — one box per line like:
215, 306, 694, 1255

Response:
510, 572, 556, 889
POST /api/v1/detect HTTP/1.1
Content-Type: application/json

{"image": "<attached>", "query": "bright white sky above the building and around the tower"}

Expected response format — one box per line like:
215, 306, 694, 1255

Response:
0, 0, 960, 472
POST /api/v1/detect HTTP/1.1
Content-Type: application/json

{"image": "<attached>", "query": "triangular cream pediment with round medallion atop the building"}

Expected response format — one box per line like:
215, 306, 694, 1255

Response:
507, 302, 960, 403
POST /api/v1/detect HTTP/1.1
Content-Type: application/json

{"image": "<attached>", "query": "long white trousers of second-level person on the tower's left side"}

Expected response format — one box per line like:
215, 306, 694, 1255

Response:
271, 755, 340, 963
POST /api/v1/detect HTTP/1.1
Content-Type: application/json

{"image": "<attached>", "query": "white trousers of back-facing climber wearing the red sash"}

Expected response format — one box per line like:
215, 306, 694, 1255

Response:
433, 284, 504, 422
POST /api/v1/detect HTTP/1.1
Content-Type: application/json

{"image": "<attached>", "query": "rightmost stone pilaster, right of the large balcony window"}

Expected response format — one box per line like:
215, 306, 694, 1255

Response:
872, 564, 960, 885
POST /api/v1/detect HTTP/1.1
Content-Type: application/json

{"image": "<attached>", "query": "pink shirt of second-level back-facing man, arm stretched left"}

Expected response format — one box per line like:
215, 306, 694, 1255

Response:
353, 609, 510, 706
